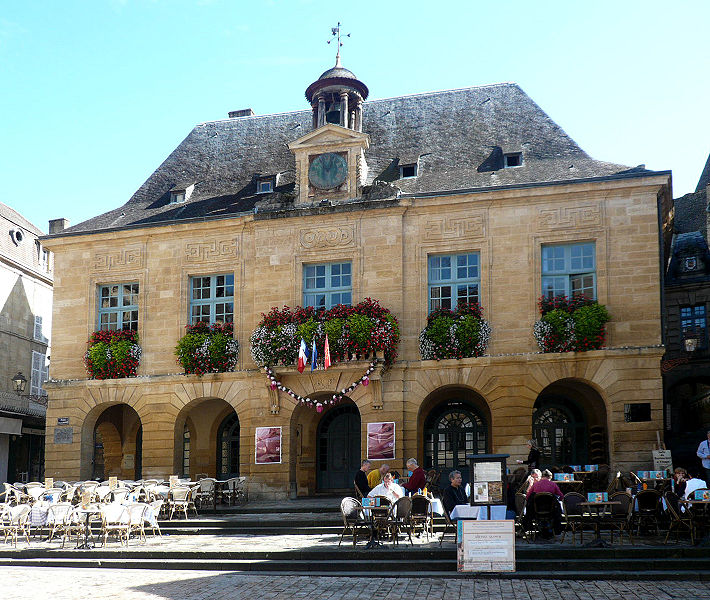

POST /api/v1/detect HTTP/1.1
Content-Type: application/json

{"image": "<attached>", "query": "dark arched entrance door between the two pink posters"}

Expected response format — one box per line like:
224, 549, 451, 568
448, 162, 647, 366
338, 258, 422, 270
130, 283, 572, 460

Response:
317, 405, 360, 490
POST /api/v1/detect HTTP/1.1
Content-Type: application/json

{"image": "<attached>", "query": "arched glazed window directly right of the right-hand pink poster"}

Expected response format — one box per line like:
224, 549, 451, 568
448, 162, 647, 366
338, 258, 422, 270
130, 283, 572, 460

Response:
424, 402, 488, 481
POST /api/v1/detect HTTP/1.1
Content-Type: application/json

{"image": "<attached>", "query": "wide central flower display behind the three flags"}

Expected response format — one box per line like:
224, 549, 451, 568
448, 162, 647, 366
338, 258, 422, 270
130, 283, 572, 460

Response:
251, 298, 399, 367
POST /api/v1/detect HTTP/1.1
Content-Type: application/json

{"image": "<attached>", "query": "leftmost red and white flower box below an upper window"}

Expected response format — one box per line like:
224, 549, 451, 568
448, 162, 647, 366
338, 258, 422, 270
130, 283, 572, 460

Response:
84, 330, 141, 379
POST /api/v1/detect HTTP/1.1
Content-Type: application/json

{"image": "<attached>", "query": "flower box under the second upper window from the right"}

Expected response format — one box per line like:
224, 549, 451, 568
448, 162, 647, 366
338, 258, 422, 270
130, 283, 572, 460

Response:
419, 302, 491, 360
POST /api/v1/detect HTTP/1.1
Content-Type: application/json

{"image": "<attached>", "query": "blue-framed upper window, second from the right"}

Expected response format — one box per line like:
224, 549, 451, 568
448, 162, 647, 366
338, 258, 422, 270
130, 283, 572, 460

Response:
429, 252, 481, 312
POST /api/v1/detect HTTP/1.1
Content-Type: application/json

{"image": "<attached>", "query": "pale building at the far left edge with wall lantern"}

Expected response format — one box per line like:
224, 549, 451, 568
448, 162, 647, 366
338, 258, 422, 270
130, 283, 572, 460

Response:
0, 203, 53, 483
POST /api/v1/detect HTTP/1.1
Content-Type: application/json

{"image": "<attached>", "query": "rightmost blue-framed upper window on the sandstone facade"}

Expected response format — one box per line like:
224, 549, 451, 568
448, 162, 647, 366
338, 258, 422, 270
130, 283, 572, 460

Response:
542, 242, 597, 299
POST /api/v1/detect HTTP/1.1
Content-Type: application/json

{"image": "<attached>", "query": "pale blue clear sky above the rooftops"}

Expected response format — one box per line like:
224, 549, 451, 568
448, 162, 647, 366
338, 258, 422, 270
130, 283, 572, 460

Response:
0, 0, 710, 232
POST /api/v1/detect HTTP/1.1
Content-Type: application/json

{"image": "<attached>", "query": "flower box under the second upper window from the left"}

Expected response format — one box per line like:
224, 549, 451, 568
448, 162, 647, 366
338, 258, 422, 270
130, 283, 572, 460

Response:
175, 321, 239, 375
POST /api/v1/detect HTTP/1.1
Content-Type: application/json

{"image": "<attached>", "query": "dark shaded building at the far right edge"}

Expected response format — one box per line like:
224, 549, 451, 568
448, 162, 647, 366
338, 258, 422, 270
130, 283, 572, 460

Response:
662, 156, 710, 467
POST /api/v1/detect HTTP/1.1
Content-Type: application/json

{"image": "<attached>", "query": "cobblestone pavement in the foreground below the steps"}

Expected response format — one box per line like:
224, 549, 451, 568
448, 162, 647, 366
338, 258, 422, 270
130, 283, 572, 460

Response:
0, 567, 710, 600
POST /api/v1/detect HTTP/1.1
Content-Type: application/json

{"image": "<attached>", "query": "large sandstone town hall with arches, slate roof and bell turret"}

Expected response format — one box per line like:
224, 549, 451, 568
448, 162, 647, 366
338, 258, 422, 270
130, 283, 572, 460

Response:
45, 58, 672, 496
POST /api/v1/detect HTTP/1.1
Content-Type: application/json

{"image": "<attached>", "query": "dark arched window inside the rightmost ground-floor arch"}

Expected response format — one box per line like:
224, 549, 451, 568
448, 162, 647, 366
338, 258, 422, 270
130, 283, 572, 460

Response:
533, 401, 587, 466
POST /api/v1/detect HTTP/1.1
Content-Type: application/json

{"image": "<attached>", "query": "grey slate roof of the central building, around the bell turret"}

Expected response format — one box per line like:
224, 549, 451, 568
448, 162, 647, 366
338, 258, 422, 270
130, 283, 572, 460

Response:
59, 83, 645, 235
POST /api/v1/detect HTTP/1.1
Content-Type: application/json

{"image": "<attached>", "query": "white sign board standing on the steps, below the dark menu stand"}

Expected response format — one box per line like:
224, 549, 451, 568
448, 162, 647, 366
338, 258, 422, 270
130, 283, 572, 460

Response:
456, 520, 515, 573
